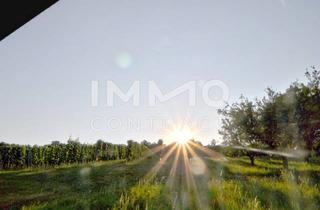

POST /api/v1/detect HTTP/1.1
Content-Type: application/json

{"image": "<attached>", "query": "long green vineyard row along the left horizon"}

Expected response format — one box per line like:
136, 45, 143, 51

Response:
0, 138, 147, 169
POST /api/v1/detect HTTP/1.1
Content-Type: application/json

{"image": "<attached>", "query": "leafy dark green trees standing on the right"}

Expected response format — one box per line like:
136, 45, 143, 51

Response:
218, 67, 320, 168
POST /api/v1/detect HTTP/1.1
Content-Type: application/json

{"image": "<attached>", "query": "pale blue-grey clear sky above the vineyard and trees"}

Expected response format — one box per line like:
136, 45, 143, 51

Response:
0, 0, 320, 145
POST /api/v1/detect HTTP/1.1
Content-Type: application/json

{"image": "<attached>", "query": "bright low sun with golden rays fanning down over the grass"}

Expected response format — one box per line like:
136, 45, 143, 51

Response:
139, 138, 225, 209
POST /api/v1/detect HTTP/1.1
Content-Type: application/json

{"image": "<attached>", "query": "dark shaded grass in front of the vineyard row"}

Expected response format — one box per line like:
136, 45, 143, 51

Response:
0, 157, 161, 209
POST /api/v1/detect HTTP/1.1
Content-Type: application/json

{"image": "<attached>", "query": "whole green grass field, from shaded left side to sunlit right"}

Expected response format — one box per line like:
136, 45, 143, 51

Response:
0, 145, 320, 210
